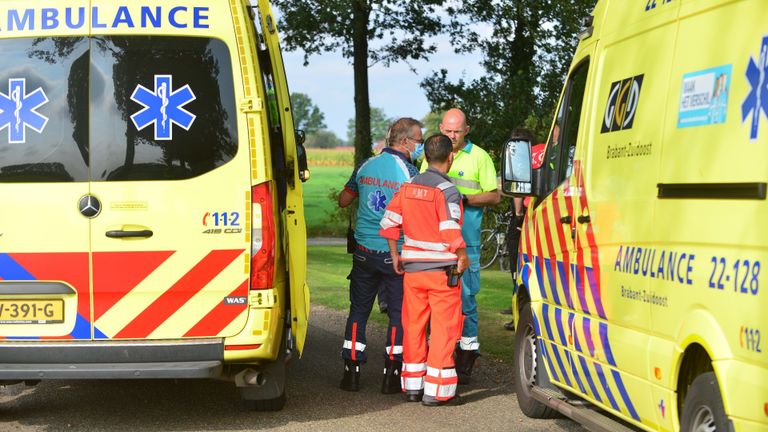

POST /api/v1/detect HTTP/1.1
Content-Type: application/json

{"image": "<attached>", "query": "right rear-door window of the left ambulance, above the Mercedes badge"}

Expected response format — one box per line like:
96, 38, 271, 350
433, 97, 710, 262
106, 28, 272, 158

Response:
90, 36, 238, 181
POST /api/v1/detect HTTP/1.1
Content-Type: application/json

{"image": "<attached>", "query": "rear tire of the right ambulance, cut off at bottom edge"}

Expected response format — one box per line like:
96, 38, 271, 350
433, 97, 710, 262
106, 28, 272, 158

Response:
680, 372, 730, 432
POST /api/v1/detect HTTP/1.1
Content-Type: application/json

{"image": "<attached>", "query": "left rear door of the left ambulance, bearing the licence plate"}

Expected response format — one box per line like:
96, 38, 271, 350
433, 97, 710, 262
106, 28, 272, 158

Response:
0, 1, 91, 341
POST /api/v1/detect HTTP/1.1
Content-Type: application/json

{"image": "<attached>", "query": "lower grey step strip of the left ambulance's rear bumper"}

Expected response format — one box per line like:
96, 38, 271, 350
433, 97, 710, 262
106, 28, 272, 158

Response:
0, 360, 222, 380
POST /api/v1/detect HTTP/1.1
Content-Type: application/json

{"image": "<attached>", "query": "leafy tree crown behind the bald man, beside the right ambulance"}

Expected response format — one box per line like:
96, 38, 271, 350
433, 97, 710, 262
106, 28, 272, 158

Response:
422, 0, 595, 153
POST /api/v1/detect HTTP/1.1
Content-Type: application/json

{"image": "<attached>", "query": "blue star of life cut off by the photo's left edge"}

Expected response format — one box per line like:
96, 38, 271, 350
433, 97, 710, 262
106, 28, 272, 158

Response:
0, 78, 48, 144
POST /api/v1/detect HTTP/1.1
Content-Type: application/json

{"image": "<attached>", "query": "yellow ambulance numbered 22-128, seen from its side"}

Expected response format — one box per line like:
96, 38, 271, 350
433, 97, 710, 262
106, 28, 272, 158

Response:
502, 0, 768, 432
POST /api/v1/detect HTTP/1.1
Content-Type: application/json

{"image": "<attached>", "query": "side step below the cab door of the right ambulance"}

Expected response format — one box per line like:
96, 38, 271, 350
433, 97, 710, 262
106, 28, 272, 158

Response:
531, 387, 636, 432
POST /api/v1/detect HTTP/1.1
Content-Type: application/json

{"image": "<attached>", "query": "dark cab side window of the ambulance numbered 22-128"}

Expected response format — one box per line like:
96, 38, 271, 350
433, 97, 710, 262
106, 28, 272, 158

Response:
542, 61, 589, 195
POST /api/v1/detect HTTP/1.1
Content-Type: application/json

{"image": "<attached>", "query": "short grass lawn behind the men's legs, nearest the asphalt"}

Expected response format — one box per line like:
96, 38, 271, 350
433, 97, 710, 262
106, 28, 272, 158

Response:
307, 246, 514, 363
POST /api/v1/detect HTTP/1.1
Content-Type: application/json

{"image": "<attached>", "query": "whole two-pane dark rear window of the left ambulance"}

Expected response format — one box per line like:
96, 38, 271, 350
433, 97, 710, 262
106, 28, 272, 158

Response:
0, 36, 238, 183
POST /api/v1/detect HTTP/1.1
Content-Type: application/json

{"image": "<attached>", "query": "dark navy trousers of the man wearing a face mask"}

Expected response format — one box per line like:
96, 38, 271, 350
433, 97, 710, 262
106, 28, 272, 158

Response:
341, 249, 403, 363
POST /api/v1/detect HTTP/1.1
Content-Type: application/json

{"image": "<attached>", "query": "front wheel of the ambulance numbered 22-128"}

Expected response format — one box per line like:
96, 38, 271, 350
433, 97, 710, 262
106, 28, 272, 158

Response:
513, 303, 559, 418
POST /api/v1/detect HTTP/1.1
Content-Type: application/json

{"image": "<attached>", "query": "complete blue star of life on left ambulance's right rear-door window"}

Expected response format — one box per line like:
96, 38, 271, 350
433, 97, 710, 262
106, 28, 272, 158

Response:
131, 75, 196, 141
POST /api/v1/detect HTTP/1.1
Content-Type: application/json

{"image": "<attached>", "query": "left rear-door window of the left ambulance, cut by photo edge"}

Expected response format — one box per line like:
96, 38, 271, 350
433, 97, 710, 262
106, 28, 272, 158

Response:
0, 37, 89, 183
